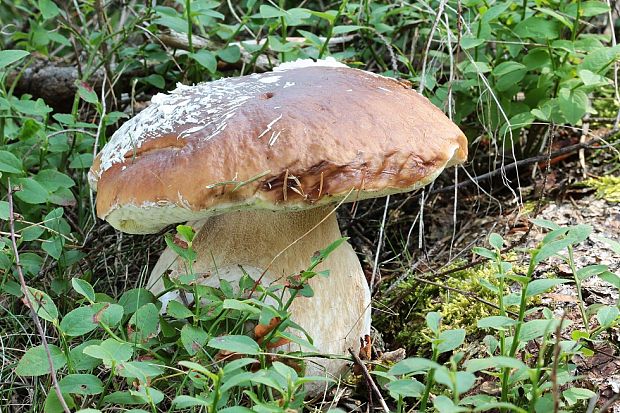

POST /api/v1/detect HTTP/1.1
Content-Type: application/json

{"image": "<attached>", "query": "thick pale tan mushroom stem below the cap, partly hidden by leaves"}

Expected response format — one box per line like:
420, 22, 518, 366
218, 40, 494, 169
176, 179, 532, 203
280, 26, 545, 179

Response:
149, 207, 370, 384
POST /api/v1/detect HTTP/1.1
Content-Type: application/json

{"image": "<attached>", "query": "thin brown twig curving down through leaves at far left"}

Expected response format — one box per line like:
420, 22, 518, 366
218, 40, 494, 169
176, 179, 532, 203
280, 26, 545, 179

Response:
8, 178, 71, 413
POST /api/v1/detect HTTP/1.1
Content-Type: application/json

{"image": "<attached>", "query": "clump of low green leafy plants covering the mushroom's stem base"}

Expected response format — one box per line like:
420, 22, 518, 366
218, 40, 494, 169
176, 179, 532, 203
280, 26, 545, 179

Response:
16, 225, 344, 413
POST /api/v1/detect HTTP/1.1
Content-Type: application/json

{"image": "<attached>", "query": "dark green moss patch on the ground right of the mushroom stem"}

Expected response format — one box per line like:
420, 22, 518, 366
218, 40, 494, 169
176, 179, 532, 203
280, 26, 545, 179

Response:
373, 264, 497, 355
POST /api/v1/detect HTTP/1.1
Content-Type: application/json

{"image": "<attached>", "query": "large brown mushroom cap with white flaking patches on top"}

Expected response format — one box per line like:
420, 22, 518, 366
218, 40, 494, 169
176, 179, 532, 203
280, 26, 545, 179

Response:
89, 59, 467, 233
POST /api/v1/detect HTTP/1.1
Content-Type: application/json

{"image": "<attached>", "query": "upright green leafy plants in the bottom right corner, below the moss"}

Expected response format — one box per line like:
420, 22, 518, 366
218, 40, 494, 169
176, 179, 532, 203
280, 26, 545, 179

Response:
375, 220, 620, 412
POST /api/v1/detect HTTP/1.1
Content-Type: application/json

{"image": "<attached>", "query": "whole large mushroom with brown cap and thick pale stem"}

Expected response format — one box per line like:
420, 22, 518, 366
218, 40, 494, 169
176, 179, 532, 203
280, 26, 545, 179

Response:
89, 59, 467, 390
